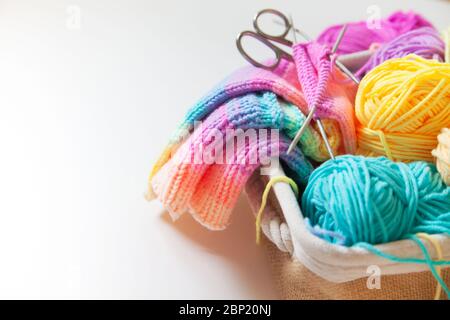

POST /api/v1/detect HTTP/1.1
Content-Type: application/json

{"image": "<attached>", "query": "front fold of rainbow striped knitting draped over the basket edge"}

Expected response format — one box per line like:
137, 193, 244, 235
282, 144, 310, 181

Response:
151, 92, 334, 230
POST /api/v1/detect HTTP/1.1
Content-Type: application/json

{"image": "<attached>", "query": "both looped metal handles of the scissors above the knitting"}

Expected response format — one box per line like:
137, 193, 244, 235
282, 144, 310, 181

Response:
236, 9, 294, 70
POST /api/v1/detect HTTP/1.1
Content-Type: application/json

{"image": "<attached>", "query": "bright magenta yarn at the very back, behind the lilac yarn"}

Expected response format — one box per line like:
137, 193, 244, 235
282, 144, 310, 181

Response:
317, 11, 433, 54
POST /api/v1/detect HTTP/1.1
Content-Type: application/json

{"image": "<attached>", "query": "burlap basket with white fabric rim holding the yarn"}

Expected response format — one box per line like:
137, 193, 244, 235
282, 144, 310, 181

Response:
245, 168, 450, 300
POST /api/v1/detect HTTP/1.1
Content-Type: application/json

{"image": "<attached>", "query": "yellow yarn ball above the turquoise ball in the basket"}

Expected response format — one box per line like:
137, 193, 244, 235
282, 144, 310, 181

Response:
355, 55, 450, 161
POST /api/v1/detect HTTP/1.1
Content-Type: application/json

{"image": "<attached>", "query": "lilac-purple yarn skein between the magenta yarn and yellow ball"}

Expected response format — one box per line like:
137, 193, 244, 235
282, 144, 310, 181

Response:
357, 27, 445, 77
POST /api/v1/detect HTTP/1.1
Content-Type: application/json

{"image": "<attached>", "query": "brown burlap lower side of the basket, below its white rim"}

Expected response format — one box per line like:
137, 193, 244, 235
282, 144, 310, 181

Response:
264, 240, 450, 300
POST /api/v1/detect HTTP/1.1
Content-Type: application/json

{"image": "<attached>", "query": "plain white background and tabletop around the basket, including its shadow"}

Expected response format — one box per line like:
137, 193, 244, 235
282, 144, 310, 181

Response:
0, 0, 450, 299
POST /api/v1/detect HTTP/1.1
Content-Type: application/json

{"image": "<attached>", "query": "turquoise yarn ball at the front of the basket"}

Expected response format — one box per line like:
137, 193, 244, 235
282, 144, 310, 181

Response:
302, 155, 450, 246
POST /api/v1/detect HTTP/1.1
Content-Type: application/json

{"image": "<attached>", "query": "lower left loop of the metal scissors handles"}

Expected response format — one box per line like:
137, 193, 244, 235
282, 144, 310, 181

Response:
236, 31, 293, 70
